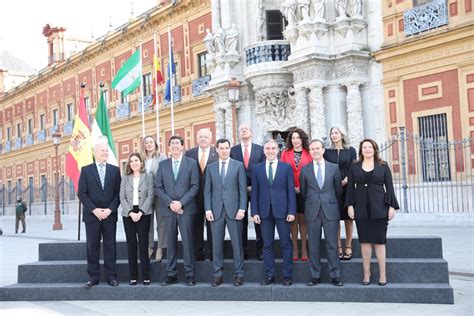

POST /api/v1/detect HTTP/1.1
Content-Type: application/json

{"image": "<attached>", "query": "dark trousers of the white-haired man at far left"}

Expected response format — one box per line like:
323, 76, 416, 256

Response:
85, 219, 117, 281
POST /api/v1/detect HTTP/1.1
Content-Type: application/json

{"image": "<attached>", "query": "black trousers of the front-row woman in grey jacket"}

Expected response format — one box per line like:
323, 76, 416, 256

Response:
123, 215, 151, 280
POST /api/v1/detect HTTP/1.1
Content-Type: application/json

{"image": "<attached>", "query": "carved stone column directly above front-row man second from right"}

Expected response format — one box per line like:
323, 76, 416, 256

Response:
309, 86, 327, 139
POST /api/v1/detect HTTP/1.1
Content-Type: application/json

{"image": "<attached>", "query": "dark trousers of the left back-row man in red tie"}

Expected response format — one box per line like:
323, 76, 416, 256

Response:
193, 197, 212, 259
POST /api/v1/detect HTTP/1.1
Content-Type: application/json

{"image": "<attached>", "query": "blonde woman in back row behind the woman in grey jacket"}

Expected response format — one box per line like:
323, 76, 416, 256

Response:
142, 135, 166, 262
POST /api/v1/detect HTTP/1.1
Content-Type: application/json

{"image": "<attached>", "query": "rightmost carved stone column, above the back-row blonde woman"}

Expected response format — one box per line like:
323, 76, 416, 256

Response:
345, 82, 364, 147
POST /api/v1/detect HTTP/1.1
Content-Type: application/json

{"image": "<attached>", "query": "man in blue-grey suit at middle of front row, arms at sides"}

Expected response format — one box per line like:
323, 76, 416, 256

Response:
204, 139, 247, 286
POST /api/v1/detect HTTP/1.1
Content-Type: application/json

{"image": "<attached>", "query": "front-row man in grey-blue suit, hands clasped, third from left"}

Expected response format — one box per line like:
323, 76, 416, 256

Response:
155, 135, 199, 286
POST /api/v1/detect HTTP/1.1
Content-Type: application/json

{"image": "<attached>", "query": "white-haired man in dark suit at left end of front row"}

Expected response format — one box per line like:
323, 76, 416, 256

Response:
78, 137, 121, 288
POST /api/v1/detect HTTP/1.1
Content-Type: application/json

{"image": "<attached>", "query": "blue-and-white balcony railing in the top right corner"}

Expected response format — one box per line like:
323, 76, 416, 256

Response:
403, 0, 448, 36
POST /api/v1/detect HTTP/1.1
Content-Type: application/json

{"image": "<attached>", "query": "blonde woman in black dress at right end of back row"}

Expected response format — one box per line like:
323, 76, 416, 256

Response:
324, 126, 357, 260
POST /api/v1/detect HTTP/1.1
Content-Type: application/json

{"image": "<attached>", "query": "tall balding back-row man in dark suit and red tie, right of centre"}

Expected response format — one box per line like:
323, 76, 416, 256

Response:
230, 123, 265, 260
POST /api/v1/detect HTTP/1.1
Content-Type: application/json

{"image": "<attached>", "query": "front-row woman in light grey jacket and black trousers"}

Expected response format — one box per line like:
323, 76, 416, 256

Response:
120, 153, 155, 285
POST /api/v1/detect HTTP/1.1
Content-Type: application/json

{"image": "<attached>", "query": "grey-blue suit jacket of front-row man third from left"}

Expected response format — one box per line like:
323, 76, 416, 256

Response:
155, 155, 199, 216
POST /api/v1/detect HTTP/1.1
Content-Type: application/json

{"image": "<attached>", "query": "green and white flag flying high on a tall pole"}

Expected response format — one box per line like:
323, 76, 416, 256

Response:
112, 49, 142, 96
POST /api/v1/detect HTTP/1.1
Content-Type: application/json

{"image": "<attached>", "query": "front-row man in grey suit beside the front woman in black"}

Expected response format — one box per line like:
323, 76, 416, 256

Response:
300, 139, 343, 286
